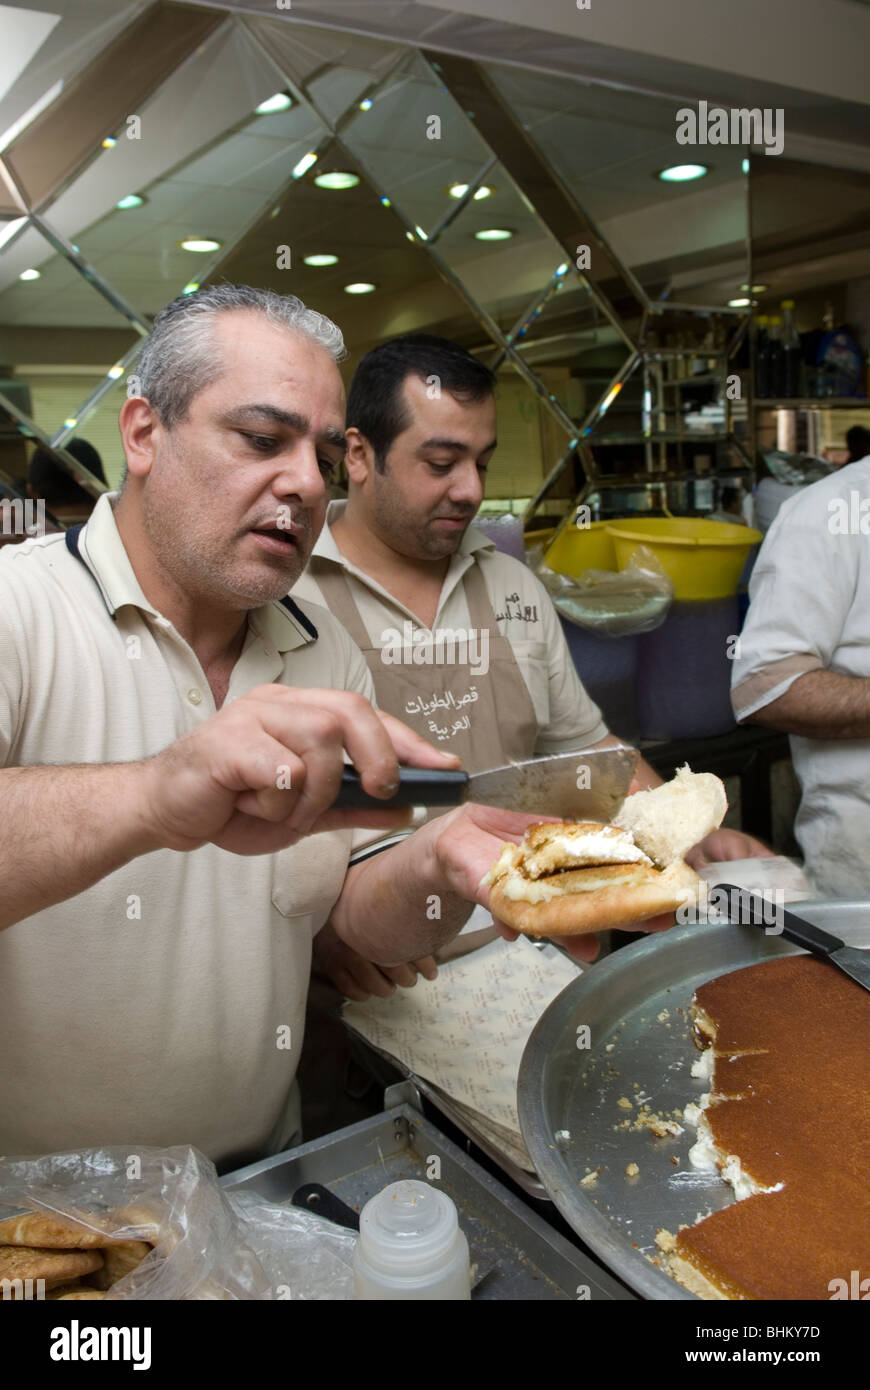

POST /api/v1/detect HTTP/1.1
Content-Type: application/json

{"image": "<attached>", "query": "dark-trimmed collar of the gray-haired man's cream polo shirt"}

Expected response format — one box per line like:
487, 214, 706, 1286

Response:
71, 492, 317, 652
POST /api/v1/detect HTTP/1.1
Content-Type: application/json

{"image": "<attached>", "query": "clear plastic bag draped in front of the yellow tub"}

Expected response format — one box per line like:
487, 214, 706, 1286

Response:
536, 545, 674, 637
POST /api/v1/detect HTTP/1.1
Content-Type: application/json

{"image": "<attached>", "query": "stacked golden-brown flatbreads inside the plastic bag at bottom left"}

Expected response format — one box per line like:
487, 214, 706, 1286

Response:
0, 1212, 157, 1301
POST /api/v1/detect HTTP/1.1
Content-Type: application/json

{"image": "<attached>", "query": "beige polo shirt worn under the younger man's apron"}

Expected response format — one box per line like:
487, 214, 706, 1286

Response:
293, 502, 609, 756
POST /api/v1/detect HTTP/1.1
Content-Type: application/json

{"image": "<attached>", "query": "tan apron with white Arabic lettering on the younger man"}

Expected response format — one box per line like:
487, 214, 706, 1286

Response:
310, 556, 538, 773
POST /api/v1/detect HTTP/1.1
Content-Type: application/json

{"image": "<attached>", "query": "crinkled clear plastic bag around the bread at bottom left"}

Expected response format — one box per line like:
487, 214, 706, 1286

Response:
0, 1145, 356, 1301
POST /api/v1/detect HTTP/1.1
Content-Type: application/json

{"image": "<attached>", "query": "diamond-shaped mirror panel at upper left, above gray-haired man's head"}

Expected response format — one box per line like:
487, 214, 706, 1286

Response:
7, 28, 324, 324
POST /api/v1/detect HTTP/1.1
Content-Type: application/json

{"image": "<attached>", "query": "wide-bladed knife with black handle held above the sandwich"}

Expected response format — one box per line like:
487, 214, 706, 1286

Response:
334, 746, 638, 824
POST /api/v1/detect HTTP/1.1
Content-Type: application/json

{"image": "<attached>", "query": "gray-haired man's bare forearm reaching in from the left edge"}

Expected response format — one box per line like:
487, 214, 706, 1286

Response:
0, 763, 160, 930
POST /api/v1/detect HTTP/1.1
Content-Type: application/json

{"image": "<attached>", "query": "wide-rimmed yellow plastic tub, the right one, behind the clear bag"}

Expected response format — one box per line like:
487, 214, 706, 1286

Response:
607, 517, 762, 599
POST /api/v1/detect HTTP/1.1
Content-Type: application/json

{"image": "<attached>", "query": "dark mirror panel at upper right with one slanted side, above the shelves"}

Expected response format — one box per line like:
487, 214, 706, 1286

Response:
486, 65, 748, 304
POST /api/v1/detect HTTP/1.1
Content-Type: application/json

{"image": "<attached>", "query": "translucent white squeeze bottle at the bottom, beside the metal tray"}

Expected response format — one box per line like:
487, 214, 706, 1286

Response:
353, 1179, 471, 1300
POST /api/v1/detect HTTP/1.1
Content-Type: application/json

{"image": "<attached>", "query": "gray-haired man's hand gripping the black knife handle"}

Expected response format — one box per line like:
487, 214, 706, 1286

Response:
140, 685, 459, 855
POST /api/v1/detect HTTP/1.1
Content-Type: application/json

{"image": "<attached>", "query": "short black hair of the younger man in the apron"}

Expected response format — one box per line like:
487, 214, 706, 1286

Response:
347, 334, 496, 473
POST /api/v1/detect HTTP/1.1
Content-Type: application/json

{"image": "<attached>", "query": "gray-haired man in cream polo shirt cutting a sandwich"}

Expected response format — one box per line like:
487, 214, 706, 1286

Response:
0, 285, 547, 1166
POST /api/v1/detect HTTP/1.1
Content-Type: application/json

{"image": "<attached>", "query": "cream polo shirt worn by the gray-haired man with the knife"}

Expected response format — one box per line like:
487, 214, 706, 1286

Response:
0, 493, 383, 1166
